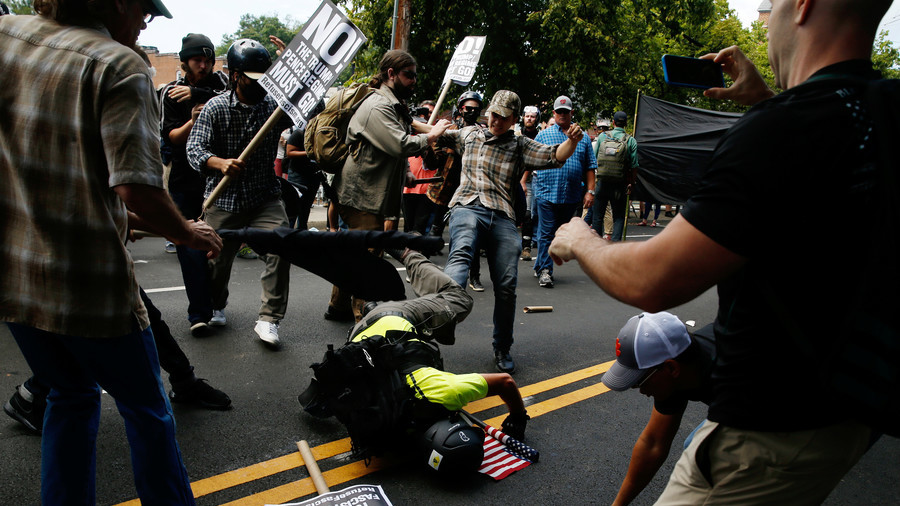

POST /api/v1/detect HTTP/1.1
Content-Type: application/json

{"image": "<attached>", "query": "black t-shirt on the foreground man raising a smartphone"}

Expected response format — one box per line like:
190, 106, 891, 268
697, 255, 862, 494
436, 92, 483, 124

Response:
682, 60, 884, 431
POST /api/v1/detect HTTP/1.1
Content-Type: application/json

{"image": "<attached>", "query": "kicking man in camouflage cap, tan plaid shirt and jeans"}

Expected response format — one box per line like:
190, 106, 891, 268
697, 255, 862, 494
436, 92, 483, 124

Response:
438, 90, 583, 373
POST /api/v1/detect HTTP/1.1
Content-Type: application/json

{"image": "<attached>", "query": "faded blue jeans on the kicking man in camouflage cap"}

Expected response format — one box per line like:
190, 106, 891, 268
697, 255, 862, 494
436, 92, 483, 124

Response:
444, 205, 522, 352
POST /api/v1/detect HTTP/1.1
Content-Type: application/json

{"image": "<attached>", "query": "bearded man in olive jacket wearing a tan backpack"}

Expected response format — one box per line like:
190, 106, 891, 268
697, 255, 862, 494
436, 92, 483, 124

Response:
325, 49, 450, 321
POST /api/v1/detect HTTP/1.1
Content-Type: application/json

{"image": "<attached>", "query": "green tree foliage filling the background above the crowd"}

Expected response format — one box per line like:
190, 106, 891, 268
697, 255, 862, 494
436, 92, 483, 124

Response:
274, 0, 900, 124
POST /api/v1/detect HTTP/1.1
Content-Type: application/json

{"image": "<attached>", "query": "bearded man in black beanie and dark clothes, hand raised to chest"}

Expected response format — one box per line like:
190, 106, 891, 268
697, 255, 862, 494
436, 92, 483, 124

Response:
160, 33, 228, 337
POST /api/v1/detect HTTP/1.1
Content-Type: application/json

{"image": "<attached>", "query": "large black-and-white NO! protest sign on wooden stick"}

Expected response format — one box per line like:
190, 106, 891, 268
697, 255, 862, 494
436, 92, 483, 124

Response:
259, 0, 366, 128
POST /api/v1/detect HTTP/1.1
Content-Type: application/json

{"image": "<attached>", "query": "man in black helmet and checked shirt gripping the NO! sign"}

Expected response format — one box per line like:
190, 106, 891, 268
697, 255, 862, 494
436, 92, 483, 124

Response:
187, 39, 291, 347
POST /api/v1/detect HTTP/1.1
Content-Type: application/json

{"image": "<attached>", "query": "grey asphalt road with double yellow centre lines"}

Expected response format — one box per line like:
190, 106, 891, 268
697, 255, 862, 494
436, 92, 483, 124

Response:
0, 209, 900, 506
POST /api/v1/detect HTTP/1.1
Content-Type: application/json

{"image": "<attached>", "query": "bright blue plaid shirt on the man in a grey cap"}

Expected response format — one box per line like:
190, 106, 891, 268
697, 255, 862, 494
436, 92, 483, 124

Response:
531, 125, 597, 204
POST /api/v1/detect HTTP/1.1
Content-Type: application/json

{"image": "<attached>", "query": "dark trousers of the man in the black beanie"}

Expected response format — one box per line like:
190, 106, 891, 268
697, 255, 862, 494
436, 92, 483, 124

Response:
169, 191, 212, 325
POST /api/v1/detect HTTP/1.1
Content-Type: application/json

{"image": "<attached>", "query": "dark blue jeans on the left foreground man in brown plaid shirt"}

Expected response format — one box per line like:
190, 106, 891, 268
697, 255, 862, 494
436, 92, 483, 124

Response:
8, 323, 194, 505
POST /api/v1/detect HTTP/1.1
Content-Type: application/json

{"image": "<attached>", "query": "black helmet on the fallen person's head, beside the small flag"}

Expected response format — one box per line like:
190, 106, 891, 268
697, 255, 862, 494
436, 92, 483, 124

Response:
420, 418, 484, 474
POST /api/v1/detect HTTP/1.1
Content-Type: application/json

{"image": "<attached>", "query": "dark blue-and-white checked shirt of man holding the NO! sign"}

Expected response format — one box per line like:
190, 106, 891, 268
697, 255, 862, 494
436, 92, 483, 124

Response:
187, 92, 291, 213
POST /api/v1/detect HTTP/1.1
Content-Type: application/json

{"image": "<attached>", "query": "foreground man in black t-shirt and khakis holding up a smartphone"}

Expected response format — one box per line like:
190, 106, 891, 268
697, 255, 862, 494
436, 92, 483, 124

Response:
551, 0, 900, 504
